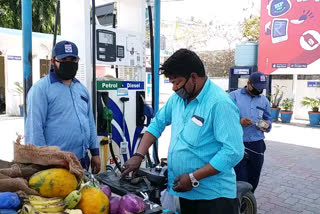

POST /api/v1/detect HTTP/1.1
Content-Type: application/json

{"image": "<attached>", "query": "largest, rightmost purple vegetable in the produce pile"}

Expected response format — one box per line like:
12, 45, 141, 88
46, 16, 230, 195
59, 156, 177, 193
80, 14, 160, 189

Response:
118, 193, 146, 214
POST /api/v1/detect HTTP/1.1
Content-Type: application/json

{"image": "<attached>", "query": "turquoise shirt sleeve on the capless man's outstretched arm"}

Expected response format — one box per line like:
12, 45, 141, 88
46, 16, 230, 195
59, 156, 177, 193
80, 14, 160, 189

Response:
147, 96, 173, 138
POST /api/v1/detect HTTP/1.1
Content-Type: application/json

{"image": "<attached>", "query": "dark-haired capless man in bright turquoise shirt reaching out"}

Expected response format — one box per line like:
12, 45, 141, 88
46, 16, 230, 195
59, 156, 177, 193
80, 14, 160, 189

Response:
122, 49, 244, 214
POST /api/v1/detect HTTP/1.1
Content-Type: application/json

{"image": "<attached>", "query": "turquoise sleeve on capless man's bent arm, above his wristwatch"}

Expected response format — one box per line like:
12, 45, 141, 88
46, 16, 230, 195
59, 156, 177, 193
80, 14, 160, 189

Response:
209, 101, 244, 171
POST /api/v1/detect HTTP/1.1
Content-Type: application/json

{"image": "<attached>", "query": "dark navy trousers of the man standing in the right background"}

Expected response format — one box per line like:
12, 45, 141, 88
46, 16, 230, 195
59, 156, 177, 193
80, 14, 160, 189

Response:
234, 140, 266, 192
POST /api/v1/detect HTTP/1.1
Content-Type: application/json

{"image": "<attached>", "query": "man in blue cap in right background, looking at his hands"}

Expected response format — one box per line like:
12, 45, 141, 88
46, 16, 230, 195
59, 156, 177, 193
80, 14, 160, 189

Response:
230, 72, 272, 191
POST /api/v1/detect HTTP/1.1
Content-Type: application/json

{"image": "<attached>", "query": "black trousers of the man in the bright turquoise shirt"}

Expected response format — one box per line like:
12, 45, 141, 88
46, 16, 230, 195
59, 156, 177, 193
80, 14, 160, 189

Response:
179, 198, 239, 214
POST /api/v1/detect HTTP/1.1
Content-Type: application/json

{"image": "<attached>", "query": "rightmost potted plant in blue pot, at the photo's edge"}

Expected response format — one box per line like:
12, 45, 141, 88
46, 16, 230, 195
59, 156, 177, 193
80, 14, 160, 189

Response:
301, 97, 320, 126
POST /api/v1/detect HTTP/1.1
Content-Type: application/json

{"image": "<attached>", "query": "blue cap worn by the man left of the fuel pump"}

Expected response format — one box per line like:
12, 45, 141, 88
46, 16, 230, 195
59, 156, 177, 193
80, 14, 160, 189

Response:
52, 41, 79, 59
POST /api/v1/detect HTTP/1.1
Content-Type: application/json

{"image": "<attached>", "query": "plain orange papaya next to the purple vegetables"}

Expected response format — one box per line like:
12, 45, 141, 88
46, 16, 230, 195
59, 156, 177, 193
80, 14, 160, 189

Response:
78, 187, 109, 214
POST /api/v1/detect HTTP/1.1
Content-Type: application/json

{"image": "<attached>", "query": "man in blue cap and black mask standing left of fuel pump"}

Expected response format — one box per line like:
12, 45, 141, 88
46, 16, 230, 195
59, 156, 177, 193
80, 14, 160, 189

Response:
25, 41, 100, 173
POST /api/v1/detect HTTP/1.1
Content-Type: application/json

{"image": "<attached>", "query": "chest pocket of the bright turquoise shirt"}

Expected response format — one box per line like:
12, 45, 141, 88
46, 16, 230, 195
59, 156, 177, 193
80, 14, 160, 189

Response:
182, 118, 202, 147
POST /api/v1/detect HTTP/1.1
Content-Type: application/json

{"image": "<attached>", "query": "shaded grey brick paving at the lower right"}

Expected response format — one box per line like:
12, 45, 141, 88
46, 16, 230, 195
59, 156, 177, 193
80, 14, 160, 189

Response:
255, 140, 320, 214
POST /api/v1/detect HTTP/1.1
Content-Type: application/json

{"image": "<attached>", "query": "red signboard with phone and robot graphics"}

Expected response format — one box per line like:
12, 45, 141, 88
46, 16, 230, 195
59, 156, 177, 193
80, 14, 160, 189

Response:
258, 0, 320, 74
